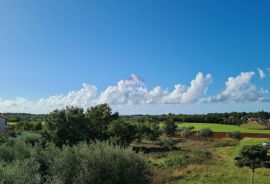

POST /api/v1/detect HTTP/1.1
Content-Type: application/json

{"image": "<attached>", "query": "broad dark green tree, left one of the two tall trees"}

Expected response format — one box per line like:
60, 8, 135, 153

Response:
44, 107, 87, 146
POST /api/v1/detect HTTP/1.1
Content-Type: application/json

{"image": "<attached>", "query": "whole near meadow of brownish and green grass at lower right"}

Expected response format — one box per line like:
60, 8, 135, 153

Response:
147, 138, 270, 184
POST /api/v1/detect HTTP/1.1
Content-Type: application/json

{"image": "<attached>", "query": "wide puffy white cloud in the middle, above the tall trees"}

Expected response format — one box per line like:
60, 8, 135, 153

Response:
98, 73, 212, 105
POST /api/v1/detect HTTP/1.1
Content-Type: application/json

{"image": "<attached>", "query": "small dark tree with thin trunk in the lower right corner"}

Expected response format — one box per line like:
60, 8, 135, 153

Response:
235, 145, 270, 184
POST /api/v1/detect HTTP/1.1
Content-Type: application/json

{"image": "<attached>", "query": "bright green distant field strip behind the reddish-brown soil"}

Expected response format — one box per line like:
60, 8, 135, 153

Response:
178, 123, 270, 134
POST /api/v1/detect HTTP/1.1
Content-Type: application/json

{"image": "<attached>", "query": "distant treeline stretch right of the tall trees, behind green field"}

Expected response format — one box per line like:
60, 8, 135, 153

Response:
122, 111, 270, 125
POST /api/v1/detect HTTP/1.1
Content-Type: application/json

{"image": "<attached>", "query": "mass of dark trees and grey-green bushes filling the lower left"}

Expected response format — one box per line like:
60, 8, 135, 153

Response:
0, 104, 155, 184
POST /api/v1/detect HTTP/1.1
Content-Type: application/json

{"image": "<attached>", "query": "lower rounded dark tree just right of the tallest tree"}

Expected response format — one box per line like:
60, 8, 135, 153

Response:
109, 119, 136, 147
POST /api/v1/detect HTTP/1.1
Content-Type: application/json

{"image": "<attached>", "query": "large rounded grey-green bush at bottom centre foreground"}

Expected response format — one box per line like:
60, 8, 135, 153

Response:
49, 143, 150, 184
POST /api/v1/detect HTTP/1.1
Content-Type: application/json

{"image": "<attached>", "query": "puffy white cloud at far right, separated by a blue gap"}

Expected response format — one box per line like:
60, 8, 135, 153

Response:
207, 72, 268, 103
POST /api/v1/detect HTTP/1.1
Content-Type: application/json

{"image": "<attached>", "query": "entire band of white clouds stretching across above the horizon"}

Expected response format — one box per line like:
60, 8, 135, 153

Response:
0, 69, 268, 113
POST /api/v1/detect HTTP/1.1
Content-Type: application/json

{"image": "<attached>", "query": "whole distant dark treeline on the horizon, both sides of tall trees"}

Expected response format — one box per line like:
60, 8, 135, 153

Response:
4, 111, 270, 125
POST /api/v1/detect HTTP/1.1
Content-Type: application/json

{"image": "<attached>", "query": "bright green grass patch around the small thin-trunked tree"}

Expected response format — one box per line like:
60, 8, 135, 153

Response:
175, 138, 270, 184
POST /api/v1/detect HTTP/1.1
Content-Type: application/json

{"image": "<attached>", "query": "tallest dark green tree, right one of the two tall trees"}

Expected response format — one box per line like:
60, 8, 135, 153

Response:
85, 104, 119, 140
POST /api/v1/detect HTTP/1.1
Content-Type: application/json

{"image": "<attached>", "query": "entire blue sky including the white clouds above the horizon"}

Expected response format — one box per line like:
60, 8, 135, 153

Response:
0, 0, 270, 114
